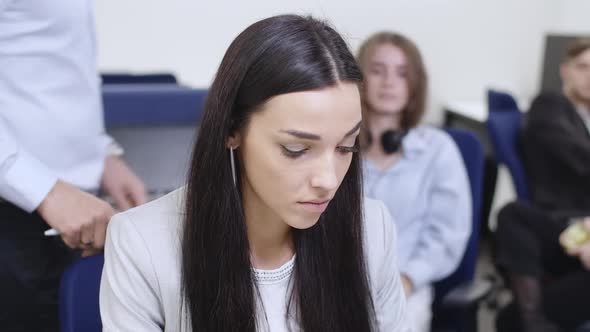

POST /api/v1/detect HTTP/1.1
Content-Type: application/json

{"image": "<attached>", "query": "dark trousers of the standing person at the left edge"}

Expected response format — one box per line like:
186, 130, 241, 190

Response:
0, 203, 78, 332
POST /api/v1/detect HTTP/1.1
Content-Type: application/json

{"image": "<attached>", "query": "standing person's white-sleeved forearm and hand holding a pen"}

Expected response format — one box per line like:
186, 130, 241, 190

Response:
0, 116, 114, 253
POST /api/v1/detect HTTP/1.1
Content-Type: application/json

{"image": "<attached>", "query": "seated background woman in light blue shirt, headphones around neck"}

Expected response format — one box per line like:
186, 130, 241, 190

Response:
357, 32, 471, 332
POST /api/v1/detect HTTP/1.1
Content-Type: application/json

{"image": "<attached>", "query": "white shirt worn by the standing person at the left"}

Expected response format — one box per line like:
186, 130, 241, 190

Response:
0, 0, 111, 212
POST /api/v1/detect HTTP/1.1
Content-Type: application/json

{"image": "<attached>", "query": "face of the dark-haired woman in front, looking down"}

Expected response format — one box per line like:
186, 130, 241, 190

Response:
235, 83, 361, 229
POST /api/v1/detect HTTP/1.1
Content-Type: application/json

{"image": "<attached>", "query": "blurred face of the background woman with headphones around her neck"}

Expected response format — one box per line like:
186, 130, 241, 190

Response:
364, 43, 409, 114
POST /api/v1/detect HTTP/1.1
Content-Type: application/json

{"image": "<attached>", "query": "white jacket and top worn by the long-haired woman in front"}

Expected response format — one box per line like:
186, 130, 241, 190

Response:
100, 189, 411, 332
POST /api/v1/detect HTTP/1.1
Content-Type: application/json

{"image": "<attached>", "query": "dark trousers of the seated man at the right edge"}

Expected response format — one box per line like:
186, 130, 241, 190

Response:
495, 202, 590, 331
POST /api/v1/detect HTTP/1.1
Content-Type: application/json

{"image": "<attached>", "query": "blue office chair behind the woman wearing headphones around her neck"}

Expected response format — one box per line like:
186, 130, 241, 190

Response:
432, 128, 493, 332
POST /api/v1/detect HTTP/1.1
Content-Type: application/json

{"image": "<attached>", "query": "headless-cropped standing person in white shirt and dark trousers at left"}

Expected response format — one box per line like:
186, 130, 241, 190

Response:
0, 0, 146, 332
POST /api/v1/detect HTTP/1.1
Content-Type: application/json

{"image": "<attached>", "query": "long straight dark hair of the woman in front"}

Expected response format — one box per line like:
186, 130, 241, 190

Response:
182, 15, 375, 332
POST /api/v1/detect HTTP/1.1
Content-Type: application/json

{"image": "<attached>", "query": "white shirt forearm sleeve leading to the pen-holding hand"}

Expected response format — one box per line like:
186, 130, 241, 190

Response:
0, 118, 57, 212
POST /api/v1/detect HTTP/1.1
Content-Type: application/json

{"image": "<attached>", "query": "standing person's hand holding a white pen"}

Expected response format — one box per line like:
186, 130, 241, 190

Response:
37, 181, 115, 254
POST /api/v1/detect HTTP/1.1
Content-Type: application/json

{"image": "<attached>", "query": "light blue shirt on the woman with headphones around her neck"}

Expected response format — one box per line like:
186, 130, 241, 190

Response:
364, 126, 472, 288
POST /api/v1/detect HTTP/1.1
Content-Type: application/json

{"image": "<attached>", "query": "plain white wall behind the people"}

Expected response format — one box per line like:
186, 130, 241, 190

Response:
96, 0, 560, 122
